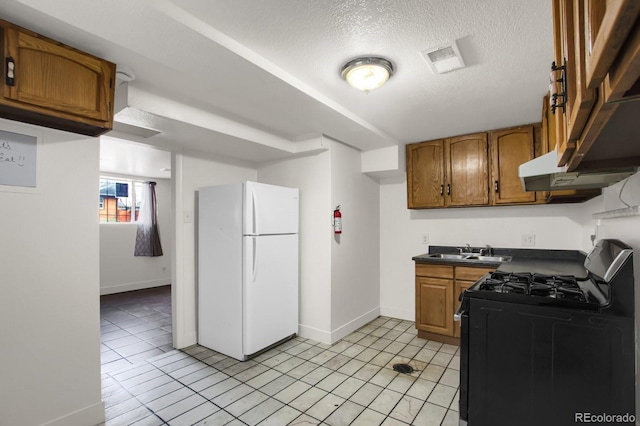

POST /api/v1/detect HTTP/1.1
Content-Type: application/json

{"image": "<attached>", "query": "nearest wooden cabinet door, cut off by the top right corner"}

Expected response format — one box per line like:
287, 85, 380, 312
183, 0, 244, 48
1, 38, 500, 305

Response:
576, 0, 640, 90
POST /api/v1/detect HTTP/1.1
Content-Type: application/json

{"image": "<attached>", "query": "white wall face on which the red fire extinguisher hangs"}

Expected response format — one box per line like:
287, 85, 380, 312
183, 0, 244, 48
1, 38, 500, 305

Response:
330, 141, 380, 341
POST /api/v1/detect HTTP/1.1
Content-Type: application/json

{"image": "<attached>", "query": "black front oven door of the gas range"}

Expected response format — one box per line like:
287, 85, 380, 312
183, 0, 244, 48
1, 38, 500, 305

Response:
460, 297, 635, 426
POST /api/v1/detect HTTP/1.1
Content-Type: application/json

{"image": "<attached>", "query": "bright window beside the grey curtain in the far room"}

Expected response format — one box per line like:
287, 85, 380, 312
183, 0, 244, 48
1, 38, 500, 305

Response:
99, 177, 143, 223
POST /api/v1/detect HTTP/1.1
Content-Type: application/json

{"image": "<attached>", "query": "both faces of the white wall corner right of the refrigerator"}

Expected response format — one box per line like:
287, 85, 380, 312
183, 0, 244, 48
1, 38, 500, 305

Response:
258, 138, 380, 343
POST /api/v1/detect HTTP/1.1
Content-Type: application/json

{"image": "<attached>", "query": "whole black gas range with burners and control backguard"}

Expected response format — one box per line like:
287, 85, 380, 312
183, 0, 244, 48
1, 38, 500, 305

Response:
456, 240, 635, 426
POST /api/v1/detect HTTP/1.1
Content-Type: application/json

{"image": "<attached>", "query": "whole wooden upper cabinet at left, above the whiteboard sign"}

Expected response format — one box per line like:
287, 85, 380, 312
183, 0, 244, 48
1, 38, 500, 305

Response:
0, 21, 115, 136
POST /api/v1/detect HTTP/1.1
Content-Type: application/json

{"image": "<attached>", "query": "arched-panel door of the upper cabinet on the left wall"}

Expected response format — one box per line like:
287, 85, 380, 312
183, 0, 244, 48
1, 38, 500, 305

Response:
4, 28, 115, 121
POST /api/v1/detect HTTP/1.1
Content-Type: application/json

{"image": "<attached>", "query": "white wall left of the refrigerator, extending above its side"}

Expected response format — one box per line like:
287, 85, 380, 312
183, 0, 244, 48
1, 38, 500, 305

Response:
171, 154, 258, 348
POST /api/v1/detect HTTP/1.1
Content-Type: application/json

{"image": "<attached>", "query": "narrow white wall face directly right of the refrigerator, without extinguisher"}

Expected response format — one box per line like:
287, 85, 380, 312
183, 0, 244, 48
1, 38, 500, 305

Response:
258, 152, 331, 343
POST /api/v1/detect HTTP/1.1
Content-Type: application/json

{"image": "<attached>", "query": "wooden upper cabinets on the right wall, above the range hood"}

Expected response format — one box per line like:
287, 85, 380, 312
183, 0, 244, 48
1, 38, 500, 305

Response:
549, 0, 640, 172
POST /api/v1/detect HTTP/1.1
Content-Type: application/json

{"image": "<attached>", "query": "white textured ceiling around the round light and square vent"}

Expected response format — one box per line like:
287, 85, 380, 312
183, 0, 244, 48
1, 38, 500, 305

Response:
0, 0, 552, 171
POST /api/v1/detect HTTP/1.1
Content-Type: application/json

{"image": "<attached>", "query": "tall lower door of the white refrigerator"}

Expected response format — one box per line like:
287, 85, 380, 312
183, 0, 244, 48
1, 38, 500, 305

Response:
244, 234, 298, 355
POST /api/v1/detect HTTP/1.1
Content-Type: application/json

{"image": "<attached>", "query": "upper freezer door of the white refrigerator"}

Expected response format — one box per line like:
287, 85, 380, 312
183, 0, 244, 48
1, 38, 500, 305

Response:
244, 182, 298, 235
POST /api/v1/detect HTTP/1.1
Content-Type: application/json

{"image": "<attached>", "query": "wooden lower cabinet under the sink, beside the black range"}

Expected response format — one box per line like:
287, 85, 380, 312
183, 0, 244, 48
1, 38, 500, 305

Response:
416, 263, 495, 345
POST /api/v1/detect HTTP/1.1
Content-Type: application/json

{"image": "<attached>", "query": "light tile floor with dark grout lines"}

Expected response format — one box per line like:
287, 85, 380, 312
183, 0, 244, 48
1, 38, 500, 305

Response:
102, 288, 460, 426
